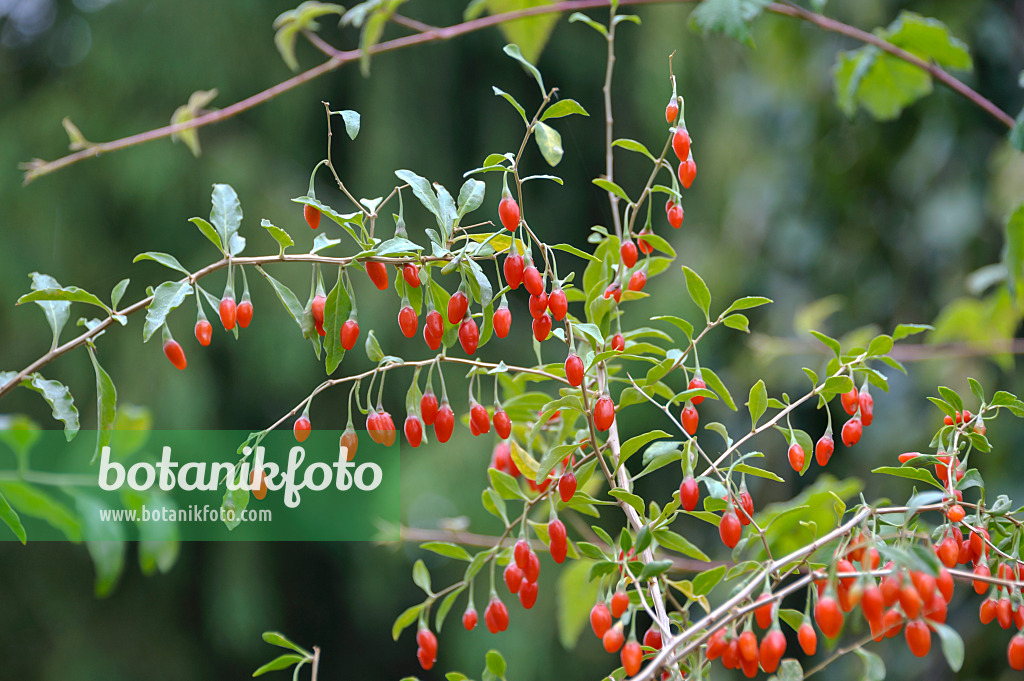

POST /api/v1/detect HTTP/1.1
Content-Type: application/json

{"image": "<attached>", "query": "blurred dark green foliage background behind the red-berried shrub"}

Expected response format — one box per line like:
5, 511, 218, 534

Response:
0, 0, 1024, 681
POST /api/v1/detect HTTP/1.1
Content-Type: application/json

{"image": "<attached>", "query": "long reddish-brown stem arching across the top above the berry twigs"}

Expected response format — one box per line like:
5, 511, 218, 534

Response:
20, 0, 1014, 184
